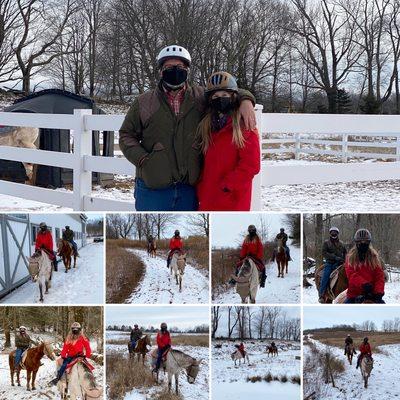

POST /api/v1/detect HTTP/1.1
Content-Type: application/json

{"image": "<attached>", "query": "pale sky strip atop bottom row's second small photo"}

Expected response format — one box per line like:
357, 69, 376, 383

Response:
106, 305, 210, 328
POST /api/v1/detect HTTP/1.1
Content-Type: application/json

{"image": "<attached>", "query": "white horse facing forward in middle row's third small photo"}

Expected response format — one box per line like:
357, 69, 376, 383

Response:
232, 258, 260, 304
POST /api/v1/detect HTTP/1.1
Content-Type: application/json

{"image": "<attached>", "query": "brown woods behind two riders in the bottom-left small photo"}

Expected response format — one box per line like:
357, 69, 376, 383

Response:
0, 306, 104, 353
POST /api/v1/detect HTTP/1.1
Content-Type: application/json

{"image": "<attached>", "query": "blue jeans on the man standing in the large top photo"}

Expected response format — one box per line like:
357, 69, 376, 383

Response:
134, 178, 199, 211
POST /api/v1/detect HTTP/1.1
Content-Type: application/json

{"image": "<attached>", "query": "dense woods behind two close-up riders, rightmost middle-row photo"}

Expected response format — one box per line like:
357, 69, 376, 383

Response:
303, 214, 400, 266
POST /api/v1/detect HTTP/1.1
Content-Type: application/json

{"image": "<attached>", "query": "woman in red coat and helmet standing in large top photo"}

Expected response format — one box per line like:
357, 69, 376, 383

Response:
197, 72, 260, 211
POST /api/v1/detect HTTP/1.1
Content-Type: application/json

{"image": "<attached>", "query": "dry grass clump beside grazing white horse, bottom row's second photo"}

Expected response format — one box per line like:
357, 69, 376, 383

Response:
107, 354, 155, 400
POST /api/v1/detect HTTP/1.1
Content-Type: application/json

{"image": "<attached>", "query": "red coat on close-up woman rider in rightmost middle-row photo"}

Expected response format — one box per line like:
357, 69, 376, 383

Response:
345, 259, 385, 298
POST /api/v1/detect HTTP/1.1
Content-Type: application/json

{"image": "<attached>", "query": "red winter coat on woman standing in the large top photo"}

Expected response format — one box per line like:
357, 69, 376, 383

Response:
197, 120, 260, 211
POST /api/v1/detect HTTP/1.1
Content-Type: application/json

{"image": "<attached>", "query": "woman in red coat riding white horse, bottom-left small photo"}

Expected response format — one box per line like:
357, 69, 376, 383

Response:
50, 322, 92, 385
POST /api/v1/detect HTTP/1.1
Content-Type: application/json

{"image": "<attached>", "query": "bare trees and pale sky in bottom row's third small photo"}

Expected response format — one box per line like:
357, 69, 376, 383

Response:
211, 306, 301, 341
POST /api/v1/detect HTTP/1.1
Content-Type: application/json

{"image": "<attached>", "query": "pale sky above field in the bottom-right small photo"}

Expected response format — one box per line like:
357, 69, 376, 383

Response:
303, 305, 400, 329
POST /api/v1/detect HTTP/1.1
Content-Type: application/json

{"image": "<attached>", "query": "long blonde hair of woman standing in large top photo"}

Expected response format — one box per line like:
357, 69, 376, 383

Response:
197, 101, 245, 153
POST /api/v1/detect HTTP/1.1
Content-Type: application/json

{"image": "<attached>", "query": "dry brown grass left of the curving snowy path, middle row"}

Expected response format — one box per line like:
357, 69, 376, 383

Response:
106, 239, 145, 303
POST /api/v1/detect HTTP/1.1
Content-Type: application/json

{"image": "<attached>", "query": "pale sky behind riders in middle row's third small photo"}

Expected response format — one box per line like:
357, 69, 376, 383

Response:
211, 213, 294, 247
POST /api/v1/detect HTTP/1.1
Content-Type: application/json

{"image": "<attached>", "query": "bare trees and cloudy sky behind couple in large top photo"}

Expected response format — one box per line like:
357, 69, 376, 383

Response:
4, 0, 400, 114
